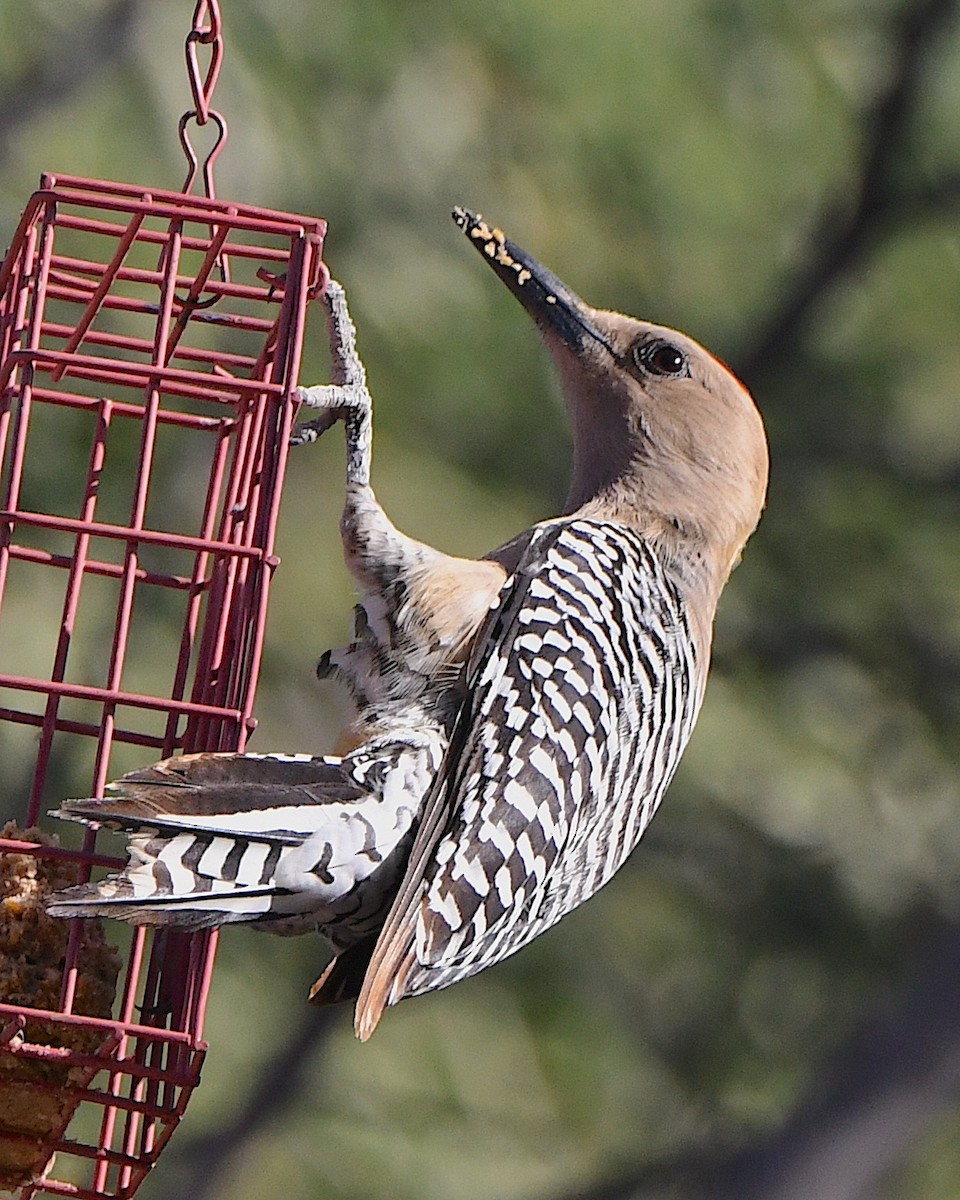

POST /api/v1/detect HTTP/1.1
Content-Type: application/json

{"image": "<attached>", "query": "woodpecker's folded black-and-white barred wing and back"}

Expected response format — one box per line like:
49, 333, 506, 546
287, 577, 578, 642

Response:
358, 520, 706, 1032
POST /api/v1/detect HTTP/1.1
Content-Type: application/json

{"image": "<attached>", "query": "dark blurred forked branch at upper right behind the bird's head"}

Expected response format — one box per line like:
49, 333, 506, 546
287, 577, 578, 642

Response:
737, 0, 960, 378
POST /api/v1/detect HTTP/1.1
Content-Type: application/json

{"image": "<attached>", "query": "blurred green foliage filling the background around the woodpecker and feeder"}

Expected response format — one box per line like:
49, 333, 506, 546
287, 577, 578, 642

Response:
0, 0, 960, 1200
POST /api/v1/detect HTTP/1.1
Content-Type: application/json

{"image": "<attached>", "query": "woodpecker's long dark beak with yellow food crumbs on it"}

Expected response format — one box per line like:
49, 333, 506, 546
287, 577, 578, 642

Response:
452, 205, 610, 354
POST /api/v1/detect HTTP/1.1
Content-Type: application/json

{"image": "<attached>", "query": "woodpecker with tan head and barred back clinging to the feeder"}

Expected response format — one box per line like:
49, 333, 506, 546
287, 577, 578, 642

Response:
50, 209, 768, 1039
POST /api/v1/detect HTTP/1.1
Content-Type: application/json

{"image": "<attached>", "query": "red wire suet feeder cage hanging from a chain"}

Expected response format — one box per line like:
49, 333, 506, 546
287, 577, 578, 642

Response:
0, 175, 328, 1200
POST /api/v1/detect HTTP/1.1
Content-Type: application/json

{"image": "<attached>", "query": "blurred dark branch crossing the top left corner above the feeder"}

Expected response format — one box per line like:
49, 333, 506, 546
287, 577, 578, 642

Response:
0, 0, 143, 161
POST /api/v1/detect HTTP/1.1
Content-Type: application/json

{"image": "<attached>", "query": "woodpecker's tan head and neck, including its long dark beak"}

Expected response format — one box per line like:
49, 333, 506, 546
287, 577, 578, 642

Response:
454, 208, 768, 604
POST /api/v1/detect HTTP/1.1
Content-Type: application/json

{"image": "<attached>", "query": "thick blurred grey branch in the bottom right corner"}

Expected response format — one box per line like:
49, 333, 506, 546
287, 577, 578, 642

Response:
535, 925, 960, 1200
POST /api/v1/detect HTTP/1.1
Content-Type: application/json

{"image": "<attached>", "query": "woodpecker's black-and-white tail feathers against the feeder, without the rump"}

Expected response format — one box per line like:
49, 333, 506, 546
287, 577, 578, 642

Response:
47, 754, 355, 929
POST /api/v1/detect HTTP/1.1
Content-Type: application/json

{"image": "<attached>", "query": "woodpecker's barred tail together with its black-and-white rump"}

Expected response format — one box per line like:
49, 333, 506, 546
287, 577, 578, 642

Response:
48, 730, 446, 948
